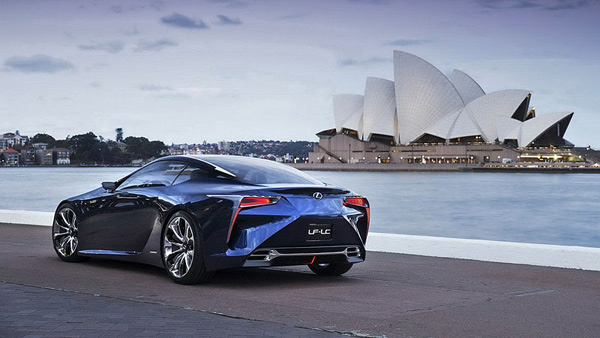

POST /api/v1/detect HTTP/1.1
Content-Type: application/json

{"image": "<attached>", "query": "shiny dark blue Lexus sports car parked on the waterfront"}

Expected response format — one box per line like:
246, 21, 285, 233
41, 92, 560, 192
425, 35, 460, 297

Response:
52, 155, 370, 284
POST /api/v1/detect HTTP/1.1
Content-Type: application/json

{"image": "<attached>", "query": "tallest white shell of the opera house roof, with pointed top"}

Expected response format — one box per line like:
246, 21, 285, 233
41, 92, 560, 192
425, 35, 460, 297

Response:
394, 51, 464, 144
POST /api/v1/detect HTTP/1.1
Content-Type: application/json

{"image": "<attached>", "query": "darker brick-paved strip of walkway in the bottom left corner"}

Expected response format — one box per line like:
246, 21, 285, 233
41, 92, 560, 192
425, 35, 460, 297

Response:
0, 283, 340, 338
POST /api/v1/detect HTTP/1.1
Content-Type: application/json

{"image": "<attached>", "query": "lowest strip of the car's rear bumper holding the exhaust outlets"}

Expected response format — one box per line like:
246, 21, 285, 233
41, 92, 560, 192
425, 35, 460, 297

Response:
243, 245, 365, 267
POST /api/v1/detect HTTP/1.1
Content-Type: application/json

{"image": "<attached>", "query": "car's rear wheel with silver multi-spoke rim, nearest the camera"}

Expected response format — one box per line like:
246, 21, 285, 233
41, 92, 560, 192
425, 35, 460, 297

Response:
161, 211, 214, 284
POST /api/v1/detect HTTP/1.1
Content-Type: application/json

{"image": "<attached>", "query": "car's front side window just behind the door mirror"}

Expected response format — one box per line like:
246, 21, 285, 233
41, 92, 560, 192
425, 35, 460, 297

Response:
118, 161, 185, 190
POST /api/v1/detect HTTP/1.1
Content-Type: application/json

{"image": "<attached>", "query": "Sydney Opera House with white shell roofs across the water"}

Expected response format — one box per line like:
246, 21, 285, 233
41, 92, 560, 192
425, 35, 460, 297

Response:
309, 51, 573, 163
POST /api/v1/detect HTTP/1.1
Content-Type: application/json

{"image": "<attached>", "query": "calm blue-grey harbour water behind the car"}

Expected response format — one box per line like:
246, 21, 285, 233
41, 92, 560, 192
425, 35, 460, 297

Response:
0, 168, 600, 247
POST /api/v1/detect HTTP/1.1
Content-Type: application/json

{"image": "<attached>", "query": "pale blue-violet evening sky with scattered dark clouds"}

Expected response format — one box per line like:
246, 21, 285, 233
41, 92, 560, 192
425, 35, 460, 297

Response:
0, 0, 600, 148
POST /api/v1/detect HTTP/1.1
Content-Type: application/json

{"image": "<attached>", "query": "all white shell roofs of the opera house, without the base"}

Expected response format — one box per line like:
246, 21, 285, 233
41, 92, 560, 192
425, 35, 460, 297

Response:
333, 51, 573, 147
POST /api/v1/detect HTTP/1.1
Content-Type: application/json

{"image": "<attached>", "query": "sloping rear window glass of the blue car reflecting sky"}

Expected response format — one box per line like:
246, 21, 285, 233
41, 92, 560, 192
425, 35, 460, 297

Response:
201, 156, 323, 185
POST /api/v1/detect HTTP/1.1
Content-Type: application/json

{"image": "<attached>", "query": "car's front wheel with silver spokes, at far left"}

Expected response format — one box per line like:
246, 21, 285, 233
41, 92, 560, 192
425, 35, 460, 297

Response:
52, 204, 89, 263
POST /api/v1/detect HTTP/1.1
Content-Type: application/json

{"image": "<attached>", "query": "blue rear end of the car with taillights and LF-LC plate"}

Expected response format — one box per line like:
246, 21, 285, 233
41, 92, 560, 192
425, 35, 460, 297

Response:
228, 186, 370, 267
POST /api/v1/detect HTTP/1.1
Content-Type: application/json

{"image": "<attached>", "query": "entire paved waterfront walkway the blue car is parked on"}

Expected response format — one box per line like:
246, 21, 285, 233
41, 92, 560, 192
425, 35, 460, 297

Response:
0, 224, 600, 337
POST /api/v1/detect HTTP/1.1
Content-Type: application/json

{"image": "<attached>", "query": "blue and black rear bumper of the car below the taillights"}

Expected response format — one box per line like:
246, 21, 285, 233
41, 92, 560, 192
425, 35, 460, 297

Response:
206, 215, 367, 271
